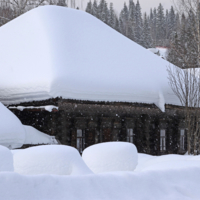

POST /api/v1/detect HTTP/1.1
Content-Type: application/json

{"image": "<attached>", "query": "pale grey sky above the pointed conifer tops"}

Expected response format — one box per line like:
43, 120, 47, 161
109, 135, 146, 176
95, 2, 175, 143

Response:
77, 0, 173, 13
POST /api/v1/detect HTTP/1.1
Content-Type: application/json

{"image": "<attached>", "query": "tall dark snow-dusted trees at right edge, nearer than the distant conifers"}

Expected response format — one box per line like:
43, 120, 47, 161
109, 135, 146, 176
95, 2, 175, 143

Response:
168, 10, 200, 68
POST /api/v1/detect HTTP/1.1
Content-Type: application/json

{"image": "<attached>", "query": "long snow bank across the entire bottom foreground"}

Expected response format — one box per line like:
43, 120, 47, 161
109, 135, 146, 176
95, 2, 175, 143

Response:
0, 168, 200, 200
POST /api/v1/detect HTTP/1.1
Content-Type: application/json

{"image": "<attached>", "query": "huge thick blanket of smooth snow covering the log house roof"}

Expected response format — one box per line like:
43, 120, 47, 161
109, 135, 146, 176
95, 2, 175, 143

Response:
0, 6, 180, 111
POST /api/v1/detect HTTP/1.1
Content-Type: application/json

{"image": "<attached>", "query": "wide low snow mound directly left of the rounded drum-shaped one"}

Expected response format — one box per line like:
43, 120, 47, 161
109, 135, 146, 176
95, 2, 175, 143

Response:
13, 145, 92, 175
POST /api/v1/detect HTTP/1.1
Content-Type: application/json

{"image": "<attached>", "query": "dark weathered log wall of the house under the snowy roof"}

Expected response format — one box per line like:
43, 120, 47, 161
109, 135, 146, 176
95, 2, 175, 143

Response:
11, 99, 185, 155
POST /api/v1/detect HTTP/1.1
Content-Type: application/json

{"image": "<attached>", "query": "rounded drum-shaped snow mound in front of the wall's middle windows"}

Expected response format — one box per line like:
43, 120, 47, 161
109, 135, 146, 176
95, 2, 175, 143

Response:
82, 142, 138, 173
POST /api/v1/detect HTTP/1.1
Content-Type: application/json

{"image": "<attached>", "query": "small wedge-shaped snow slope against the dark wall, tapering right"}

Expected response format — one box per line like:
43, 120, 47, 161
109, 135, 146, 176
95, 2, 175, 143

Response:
24, 125, 58, 144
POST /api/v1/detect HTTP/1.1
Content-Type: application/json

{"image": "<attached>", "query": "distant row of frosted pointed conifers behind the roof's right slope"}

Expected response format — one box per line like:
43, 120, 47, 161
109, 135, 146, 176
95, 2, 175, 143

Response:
86, 0, 180, 48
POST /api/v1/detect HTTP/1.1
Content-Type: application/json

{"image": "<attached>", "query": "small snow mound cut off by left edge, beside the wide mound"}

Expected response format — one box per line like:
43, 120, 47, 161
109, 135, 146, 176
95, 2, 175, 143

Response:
0, 145, 14, 172
